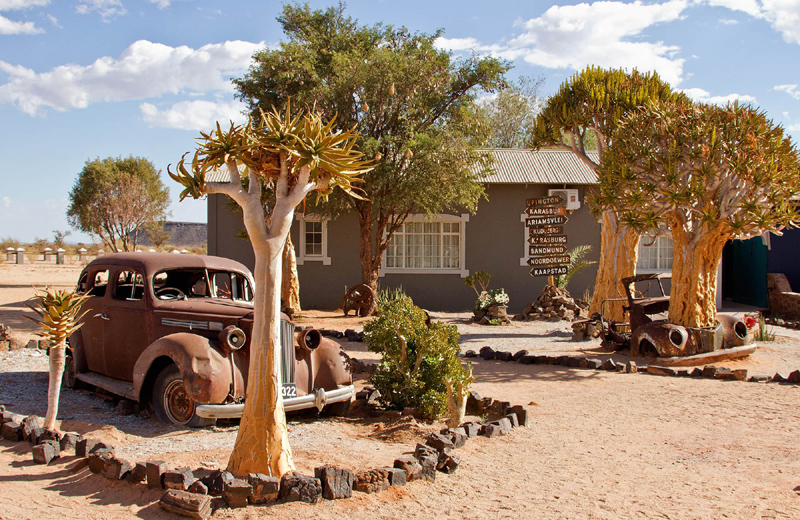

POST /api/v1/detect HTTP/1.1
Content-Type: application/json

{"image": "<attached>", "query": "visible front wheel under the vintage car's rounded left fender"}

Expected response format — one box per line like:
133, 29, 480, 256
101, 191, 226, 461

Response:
153, 365, 216, 428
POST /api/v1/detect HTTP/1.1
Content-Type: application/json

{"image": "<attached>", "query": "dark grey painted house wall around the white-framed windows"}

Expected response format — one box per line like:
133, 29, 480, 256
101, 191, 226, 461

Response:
208, 184, 600, 313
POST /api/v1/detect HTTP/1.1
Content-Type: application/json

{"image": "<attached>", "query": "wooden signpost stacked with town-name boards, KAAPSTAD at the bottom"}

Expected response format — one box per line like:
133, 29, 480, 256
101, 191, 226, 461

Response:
525, 195, 569, 285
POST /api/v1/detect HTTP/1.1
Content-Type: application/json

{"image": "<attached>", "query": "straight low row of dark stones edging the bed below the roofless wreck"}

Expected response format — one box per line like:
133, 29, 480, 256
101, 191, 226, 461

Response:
464, 347, 800, 384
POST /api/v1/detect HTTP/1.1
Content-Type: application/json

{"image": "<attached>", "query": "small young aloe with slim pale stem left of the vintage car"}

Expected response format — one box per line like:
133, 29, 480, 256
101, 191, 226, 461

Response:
26, 287, 89, 430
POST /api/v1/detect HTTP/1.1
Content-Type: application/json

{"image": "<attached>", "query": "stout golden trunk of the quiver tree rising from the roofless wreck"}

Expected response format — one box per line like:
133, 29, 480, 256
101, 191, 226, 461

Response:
669, 226, 729, 327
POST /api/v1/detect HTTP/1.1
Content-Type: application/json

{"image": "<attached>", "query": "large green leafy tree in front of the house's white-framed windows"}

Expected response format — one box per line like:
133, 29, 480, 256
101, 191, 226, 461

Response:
234, 3, 508, 308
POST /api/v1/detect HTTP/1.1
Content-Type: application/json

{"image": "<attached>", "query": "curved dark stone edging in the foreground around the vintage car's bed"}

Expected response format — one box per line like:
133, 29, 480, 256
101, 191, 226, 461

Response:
0, 392, 529, 519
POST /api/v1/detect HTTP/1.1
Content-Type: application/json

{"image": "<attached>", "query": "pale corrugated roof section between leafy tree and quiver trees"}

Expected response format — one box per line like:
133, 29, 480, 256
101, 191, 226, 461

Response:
483, 148, 598, 184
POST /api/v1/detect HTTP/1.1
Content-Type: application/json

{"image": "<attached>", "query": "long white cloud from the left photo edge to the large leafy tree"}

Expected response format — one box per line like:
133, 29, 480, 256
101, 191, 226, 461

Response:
0, 40, 264, 115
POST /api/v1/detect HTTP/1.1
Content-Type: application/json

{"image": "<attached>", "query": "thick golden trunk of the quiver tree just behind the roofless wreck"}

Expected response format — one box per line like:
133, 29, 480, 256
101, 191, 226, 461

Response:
589, 210, 639, 321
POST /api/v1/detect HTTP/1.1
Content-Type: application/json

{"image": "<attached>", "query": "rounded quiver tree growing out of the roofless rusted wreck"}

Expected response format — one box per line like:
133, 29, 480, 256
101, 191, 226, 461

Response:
599, 102, 800, 327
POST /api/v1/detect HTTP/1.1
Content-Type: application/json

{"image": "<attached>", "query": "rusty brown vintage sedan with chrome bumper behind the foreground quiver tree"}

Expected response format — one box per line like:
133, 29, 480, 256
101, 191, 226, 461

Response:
64, 253, 353, 427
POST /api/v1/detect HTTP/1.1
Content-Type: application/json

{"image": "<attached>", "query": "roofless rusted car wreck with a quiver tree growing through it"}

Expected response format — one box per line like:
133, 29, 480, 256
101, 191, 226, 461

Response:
600, 274, 753, 357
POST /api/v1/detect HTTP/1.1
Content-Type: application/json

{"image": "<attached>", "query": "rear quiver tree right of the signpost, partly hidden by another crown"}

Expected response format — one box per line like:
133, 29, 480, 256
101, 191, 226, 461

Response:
529, 67, 684, 321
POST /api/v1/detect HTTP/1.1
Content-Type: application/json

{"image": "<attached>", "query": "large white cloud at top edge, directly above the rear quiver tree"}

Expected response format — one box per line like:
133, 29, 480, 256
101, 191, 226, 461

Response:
437, 0, 687, 85
